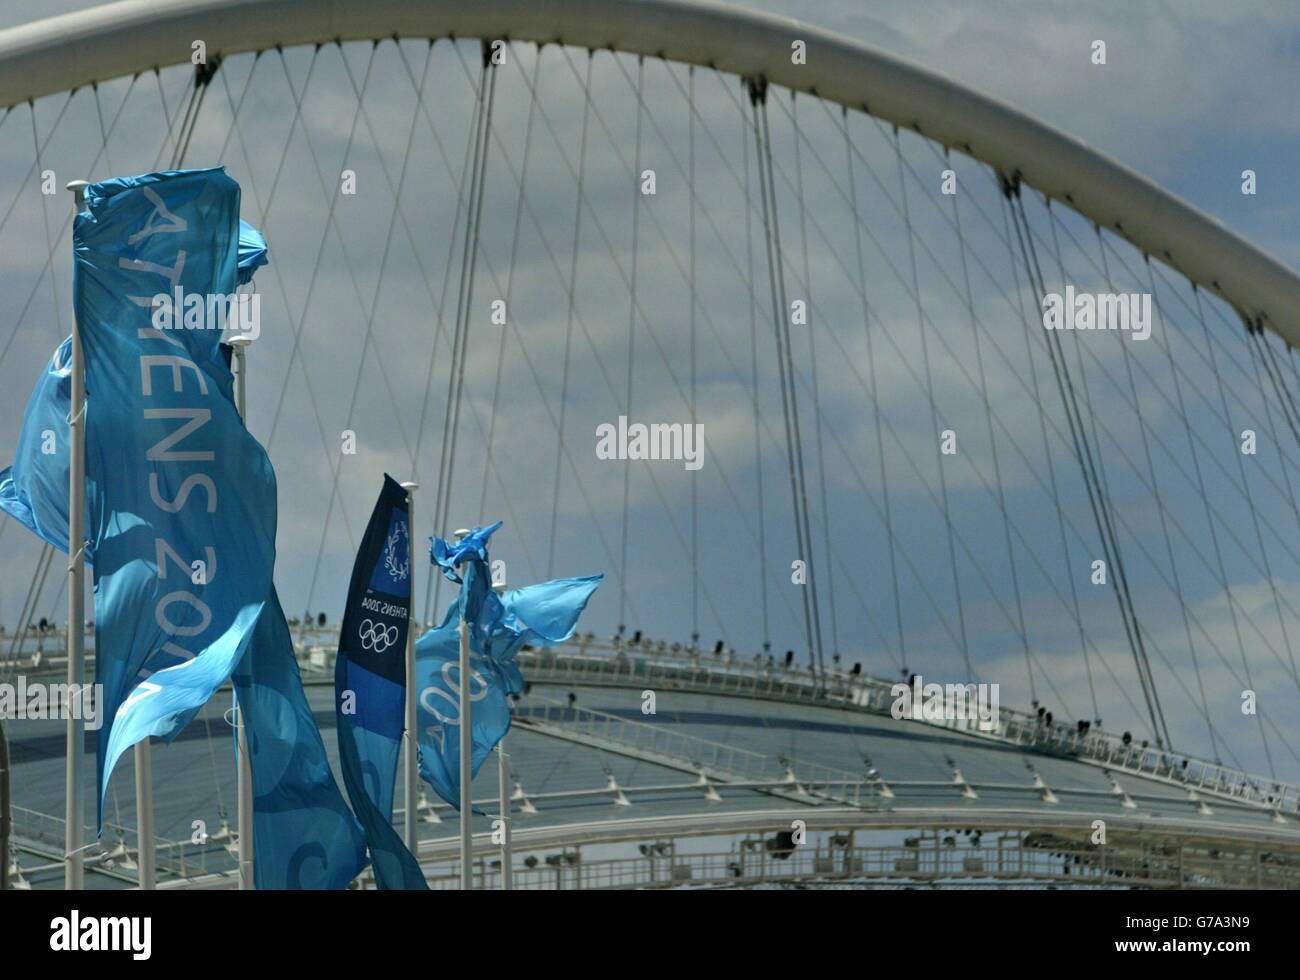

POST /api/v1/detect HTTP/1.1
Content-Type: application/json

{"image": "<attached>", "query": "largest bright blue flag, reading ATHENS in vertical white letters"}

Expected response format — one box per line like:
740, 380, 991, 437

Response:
73, 169, 276, 818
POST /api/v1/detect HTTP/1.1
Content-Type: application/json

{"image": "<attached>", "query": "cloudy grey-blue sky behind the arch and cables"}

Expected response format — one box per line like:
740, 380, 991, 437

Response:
0, 0, 1300, 779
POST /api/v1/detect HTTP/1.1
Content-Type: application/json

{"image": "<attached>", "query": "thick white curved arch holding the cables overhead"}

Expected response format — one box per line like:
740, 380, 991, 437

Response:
0, 0, 1300, 346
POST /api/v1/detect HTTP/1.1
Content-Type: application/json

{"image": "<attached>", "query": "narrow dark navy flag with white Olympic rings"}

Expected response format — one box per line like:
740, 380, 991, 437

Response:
334, 474, 428, 889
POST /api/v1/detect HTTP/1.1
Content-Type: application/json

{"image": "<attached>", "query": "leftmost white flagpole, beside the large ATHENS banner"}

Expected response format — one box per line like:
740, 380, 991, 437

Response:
64, 181, 90, 890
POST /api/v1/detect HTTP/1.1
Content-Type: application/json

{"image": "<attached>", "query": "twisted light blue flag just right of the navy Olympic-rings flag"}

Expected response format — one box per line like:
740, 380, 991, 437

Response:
416, 521, 605, 808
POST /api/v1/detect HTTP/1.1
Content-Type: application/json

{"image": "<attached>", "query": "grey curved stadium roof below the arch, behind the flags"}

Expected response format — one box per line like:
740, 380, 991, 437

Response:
13, 636, 1300, 886
